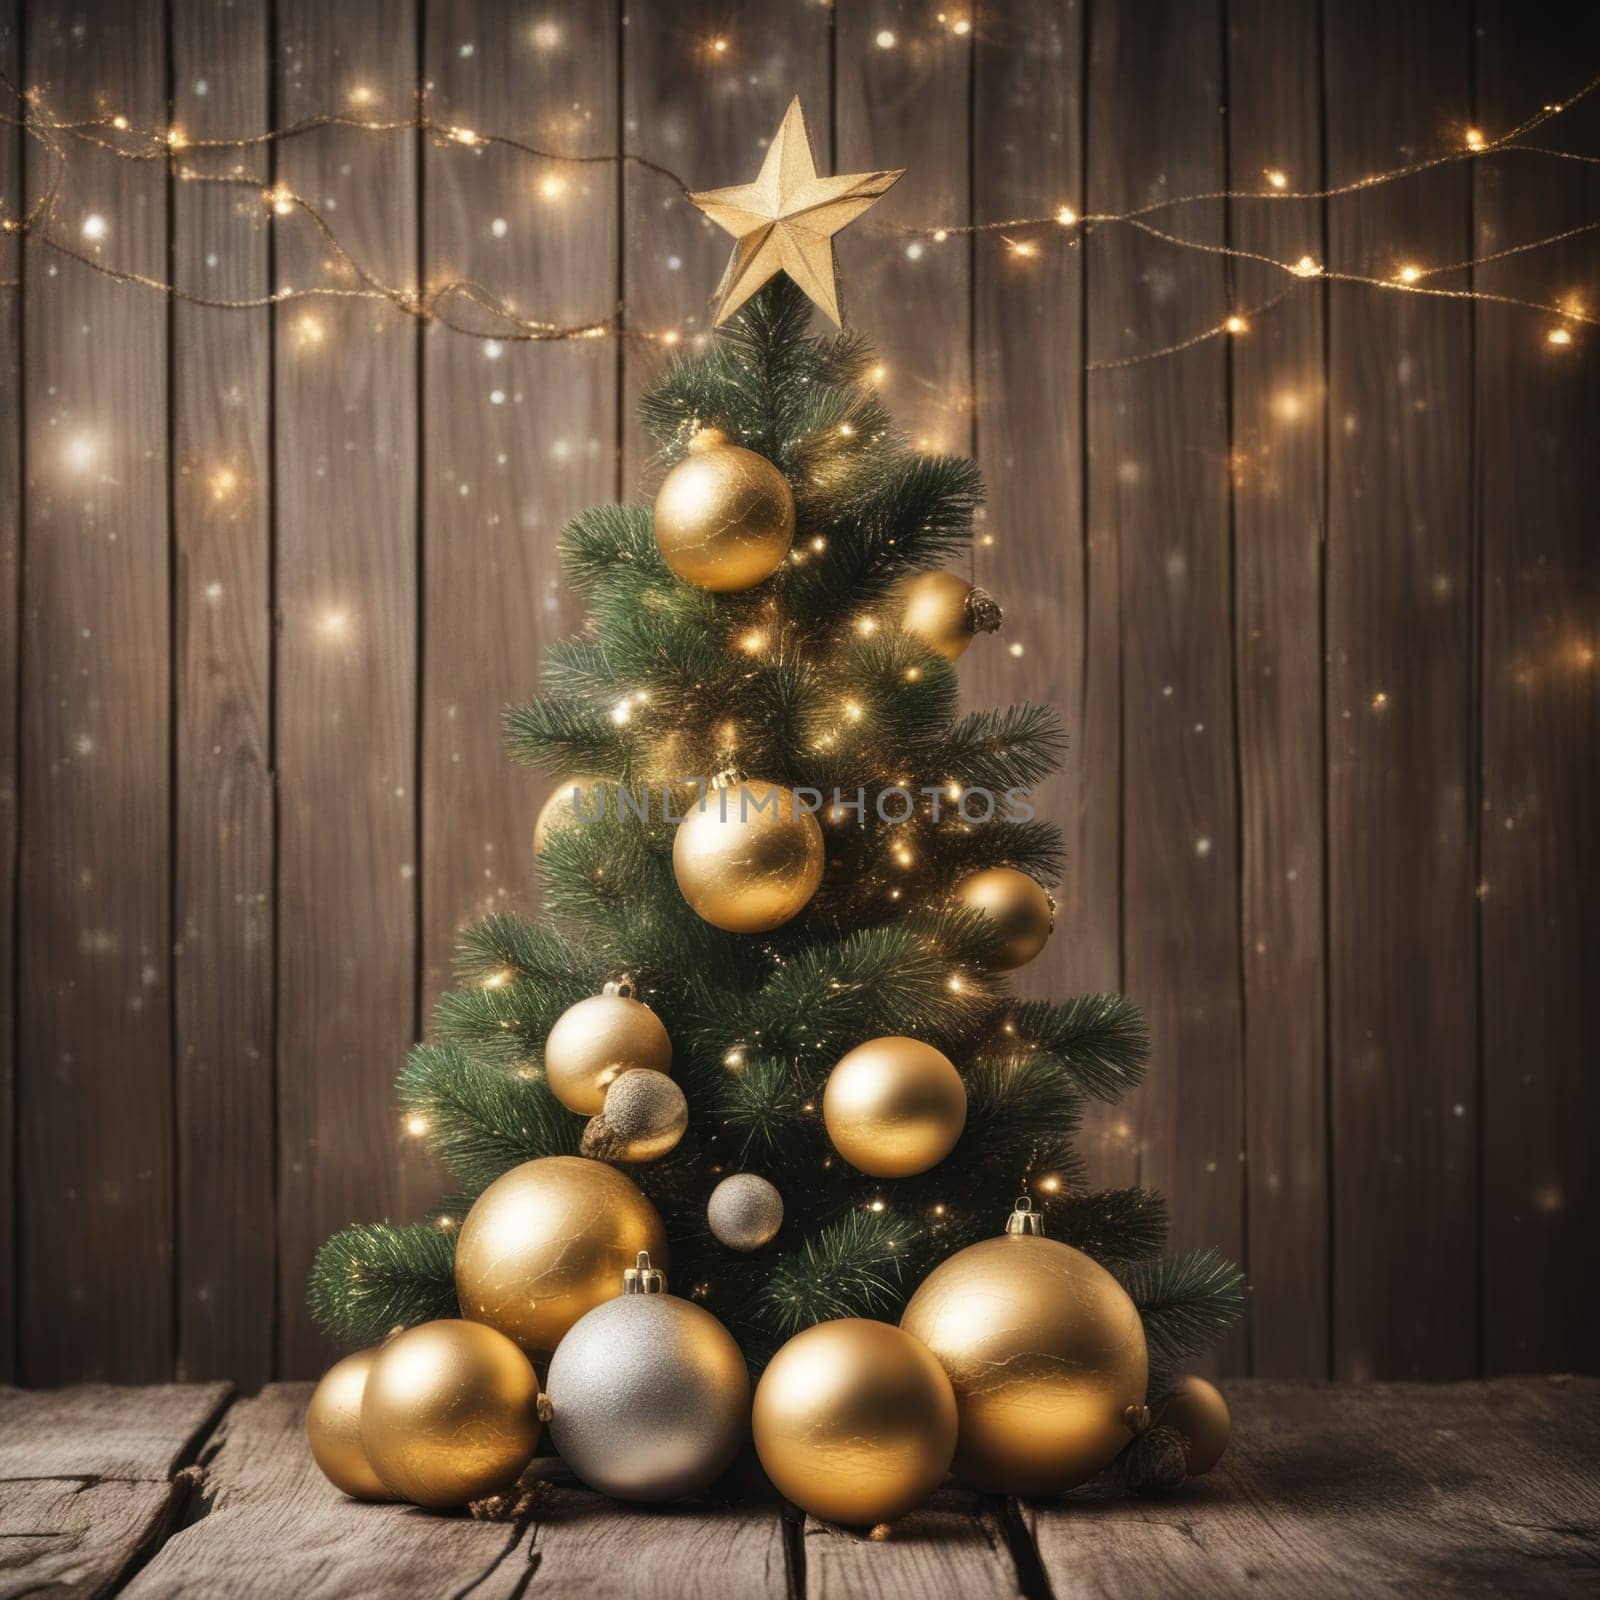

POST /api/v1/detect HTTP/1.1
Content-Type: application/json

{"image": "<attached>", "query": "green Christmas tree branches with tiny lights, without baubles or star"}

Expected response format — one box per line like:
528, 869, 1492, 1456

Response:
310, 278, 1242, 1401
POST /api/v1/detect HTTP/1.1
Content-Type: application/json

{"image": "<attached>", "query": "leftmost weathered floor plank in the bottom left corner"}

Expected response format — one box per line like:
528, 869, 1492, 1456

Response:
0, 1384, 227, 1597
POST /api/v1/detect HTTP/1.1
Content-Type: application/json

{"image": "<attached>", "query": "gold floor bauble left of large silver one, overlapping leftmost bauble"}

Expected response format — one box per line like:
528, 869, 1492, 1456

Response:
362, 1318, 539, 1510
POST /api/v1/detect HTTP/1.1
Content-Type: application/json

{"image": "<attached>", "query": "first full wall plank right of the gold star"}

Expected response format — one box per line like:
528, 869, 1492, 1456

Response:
962, 0, 1134, 1182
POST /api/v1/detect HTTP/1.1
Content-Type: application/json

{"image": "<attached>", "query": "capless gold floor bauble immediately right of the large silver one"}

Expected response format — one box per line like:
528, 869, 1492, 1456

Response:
754, 1317, 955, 1523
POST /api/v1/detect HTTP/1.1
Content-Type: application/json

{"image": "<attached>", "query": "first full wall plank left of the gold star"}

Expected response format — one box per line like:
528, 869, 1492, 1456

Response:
421, 0, 619, 1014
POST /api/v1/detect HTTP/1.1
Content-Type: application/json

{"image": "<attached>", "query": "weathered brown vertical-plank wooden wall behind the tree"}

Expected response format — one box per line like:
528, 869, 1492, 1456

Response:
0, 0, 1600, 1386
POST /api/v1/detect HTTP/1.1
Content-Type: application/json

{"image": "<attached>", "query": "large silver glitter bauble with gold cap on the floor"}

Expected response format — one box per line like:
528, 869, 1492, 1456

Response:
546, 1256, 750, 1501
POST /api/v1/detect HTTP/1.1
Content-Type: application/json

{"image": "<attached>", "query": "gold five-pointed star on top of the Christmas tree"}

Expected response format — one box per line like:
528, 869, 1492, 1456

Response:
690, 96, 906, 326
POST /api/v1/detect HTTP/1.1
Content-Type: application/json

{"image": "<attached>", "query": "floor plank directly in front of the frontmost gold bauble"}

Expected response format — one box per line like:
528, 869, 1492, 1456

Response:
802, 1486, 1019, 1600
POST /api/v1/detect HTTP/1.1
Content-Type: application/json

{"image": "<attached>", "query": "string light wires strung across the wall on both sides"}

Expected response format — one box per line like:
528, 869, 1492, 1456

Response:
0, 75, 1600, 371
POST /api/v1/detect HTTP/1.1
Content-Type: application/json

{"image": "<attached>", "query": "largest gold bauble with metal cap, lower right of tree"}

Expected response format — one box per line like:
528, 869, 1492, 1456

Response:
901, 1202, 1149, 1494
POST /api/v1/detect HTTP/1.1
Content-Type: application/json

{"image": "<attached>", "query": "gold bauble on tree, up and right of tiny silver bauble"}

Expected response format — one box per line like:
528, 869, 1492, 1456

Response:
822, 1034, 966, 1178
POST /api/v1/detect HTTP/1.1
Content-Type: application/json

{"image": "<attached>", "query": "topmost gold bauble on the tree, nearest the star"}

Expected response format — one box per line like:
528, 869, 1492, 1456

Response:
656, 427, 795, 594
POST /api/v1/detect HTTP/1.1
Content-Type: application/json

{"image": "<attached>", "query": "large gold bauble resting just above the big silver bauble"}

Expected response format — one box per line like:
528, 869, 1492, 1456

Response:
456, 1155, 667, 1355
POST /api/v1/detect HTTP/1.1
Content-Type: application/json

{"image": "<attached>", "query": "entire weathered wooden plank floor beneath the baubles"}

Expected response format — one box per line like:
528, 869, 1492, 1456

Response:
0, 1378, 1600, 1600
